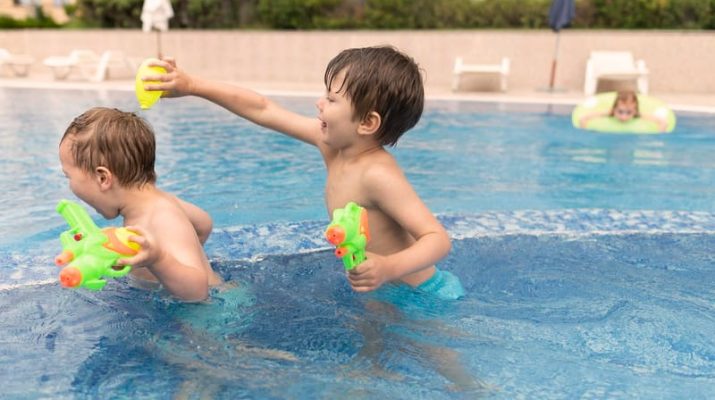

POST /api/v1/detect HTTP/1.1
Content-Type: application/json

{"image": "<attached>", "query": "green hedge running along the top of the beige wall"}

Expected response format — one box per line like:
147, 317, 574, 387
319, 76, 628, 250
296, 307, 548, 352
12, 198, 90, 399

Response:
14, 0, 715, 30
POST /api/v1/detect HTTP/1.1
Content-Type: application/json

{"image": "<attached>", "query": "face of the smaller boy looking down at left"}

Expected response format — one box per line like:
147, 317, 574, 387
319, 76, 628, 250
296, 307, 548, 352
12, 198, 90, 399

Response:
60, 138, 117, 219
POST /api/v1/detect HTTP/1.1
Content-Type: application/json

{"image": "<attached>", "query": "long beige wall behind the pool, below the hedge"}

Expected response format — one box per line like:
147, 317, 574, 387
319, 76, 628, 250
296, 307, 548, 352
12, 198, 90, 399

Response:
0, 29, 715, 94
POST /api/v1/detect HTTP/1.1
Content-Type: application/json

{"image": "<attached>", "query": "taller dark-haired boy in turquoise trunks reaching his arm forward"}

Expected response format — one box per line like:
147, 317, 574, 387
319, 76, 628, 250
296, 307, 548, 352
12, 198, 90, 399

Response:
144, 46, 464, 299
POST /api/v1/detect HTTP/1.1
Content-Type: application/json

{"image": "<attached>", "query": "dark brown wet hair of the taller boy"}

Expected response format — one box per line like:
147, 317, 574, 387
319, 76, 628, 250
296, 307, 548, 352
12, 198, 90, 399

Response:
324, 46, 424, 146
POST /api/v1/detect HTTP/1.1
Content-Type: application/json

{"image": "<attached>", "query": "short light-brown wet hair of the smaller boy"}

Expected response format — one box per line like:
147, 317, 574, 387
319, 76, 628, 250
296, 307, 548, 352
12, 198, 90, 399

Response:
60, 107, 156, 187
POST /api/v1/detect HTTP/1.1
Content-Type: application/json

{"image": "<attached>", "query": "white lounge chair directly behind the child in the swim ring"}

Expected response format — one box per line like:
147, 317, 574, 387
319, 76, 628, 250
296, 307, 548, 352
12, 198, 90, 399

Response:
583, 51, 648, 96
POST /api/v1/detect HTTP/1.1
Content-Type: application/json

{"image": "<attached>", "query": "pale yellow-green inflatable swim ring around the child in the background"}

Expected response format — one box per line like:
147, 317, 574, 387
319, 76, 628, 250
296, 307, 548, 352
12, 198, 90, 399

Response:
571, 92, 675, 134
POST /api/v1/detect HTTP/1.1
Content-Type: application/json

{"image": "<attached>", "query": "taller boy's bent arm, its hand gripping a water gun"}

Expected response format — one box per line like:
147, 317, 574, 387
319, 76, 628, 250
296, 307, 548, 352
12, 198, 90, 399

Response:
348, 166, 452, 292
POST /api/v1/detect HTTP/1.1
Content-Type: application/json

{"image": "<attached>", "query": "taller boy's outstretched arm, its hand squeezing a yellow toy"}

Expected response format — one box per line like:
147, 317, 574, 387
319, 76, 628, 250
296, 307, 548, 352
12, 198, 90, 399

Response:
144, 58, 320, 146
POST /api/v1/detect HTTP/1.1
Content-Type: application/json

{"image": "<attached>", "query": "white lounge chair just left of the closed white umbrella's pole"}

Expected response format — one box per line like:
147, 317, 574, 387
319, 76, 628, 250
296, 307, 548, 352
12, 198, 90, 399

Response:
43, 49, 135, 82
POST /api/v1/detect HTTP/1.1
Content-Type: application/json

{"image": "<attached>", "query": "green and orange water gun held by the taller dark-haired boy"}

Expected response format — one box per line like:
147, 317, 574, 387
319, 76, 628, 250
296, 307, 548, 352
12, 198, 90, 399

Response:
325, 201, 370, 271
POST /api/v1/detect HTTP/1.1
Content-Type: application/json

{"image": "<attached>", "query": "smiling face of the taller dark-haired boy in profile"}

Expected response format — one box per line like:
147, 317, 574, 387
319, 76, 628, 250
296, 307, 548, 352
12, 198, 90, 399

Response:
315, 71, 359, 148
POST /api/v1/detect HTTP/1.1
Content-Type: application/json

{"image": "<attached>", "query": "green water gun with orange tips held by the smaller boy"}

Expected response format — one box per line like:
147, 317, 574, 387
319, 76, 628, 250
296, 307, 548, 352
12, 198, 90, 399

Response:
55, 200, 140, 290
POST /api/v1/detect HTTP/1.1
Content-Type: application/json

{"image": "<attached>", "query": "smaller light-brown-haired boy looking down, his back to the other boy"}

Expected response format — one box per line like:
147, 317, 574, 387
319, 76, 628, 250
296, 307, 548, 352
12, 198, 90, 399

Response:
59, 107, 221, 301
